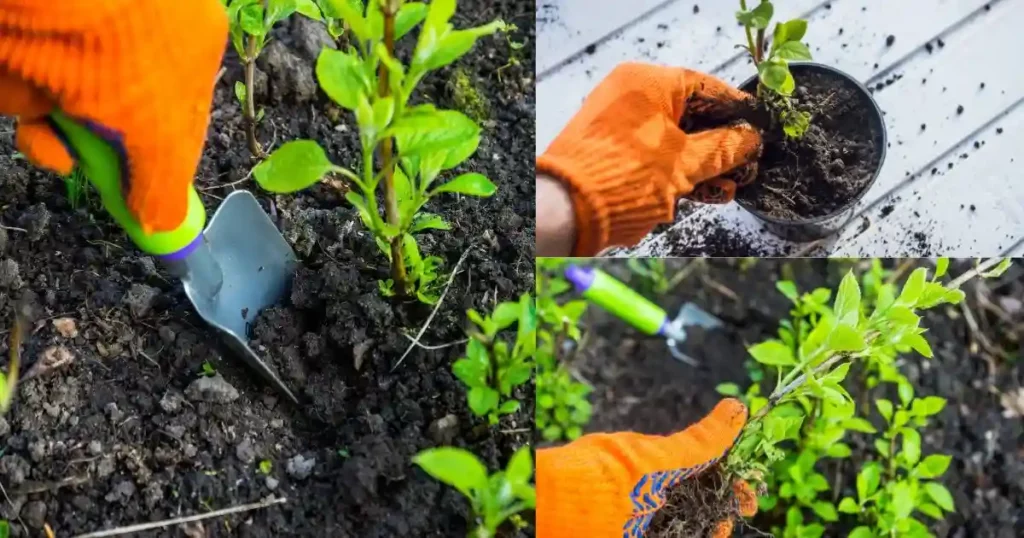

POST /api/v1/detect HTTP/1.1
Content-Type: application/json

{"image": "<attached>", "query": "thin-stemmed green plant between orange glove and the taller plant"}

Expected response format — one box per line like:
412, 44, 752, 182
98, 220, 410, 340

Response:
220, 0, 322, 159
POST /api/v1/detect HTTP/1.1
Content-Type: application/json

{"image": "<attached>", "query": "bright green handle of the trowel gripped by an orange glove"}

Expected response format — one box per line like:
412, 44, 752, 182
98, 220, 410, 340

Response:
50, 111, 206, 256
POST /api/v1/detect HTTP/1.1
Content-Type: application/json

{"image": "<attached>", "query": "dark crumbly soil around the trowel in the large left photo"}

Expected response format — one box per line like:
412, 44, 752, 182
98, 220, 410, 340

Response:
0, 0, 536, 538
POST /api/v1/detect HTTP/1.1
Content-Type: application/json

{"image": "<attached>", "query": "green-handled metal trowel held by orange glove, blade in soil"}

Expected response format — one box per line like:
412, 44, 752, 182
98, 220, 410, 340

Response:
51, 112, 298, 403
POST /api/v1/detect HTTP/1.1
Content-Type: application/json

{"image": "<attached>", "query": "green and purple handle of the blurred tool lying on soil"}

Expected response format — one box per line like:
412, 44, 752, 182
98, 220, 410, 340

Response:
565, 265, 669, 335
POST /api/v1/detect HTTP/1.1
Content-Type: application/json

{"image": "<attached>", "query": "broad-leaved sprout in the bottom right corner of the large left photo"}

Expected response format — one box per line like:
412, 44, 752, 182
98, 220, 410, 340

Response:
413, 446, 537, 538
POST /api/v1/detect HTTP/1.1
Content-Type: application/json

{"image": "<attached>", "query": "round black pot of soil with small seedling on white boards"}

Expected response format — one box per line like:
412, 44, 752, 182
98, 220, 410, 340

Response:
724, 0, 886, 241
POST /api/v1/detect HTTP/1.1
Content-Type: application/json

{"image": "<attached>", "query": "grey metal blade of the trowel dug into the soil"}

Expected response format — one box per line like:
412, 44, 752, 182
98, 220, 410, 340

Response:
182, 191, 298, 403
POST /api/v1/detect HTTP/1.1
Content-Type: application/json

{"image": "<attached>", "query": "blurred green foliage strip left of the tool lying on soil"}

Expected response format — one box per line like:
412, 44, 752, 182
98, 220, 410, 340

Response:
535, 258, 592, 442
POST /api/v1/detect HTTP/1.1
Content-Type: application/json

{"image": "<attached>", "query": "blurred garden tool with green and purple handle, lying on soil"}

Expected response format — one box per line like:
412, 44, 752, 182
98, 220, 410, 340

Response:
565, 265, 723, 366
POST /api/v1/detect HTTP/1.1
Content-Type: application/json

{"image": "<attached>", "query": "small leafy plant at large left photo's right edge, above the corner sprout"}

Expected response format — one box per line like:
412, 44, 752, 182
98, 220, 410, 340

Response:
452, 294, 537, 425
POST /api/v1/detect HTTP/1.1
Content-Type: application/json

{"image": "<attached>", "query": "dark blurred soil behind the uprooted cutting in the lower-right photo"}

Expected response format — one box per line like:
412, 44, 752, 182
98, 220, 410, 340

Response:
571, 258, 1024, 538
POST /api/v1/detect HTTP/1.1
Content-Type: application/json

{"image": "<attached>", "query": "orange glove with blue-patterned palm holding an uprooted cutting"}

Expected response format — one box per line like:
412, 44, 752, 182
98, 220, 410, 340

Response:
537, 399, 757, 538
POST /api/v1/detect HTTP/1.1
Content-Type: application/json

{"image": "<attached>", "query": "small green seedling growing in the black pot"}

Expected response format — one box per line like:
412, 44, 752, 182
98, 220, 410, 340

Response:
736, 0, 811, 138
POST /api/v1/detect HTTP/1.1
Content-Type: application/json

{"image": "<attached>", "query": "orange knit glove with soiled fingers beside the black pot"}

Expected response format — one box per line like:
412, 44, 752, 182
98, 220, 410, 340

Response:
537, 64, 761, 256
